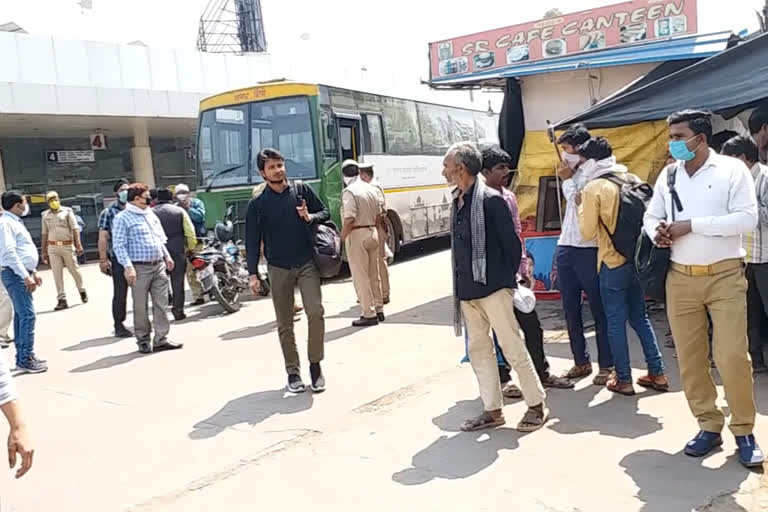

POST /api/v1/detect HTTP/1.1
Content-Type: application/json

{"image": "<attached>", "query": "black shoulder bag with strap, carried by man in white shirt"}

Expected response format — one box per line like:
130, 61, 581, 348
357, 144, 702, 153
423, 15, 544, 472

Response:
635, 166, 683, 302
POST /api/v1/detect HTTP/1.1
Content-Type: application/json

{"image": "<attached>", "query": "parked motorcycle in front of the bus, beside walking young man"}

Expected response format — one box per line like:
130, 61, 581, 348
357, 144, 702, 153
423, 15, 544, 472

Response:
190, 207, 269, 313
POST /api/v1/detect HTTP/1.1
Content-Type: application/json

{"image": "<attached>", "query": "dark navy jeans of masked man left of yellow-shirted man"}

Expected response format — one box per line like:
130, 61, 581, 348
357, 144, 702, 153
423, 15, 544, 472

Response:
555, 246, 613, 368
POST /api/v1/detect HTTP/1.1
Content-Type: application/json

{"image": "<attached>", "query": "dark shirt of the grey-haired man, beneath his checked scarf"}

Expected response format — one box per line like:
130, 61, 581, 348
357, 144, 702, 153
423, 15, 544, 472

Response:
453, 181, 522, 302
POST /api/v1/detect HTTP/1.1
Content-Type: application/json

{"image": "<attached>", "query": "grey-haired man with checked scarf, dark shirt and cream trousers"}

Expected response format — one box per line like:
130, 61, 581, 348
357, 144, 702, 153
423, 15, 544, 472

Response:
443, 142, 549, 432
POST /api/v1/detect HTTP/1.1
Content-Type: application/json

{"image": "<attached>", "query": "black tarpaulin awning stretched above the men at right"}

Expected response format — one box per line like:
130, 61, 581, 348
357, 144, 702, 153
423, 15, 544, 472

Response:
557, 34, 768, 128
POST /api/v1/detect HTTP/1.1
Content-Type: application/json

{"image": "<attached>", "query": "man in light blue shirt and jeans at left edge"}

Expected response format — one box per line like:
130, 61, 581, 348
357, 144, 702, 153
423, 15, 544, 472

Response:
0, 190, 48, 373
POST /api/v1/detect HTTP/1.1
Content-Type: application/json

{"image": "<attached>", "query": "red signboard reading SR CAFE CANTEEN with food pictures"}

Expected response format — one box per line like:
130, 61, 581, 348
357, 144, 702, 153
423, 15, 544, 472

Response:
429, 0, 698, 79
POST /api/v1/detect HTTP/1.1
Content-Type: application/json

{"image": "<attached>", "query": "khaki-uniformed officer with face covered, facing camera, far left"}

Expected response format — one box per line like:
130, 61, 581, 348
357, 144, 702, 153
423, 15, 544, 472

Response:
41, 192, 88, 311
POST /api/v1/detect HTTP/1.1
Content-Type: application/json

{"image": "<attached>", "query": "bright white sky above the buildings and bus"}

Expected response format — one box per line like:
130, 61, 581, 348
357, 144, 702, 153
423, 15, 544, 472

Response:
0, 0, 764, 108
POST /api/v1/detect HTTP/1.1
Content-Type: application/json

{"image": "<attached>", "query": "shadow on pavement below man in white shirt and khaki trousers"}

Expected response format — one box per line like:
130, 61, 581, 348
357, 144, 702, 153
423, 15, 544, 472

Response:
620, 450, 750, 512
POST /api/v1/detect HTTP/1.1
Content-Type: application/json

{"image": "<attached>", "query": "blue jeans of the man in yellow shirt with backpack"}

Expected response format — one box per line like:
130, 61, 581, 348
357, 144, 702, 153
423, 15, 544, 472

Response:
600, 263, 664, 382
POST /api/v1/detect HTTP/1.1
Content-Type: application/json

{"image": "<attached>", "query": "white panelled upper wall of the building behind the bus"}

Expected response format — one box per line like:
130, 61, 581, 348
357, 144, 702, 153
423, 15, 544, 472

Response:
0, 32, 272, 118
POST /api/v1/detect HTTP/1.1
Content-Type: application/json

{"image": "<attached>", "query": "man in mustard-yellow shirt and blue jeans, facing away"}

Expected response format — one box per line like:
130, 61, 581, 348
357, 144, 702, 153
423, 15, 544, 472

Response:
578, 137, 669, 396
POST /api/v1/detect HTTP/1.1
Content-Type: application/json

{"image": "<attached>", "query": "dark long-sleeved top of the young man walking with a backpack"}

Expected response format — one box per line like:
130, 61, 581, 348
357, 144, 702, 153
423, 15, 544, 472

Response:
245, 184, 330, 275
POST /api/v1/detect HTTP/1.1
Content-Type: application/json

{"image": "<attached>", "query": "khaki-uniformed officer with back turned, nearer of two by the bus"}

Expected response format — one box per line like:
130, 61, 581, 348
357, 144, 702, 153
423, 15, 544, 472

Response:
341, 160, 384, 327
